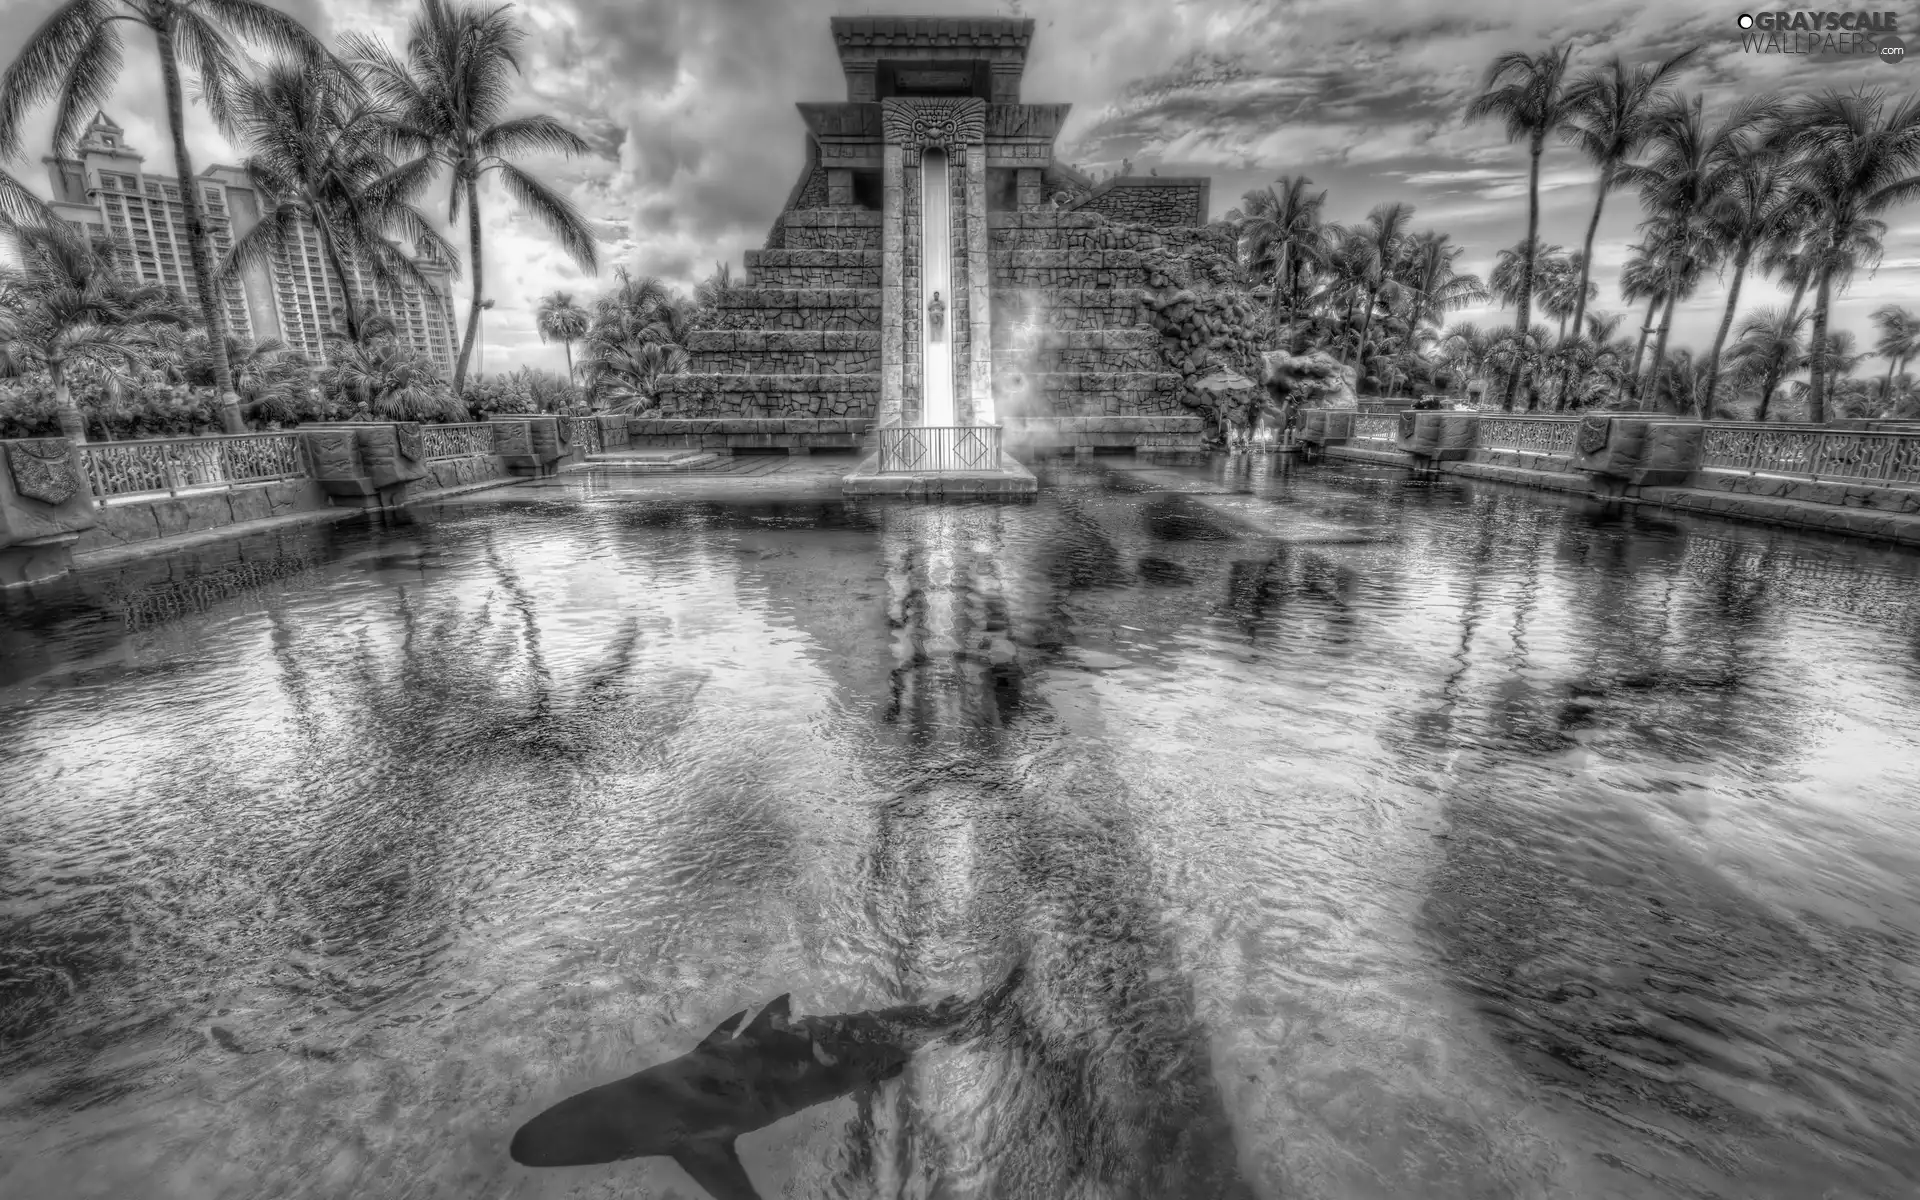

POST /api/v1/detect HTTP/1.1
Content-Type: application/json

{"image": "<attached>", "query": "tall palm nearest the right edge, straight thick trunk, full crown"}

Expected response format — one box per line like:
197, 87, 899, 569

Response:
1780, 90, 1920, 424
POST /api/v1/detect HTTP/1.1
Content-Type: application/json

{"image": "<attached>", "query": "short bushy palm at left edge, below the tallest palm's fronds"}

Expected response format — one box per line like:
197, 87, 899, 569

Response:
0, 225, 188, 444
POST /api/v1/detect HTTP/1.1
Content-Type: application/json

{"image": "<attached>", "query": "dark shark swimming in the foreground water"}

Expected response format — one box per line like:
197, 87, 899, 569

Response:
509, 968, 1025, 1200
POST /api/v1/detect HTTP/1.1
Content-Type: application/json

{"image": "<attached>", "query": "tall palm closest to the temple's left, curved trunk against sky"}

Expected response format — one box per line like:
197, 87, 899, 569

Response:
348, 0, 599, 394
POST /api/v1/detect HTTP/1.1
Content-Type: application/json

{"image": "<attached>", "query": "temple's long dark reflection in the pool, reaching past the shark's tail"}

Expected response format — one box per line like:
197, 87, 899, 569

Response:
833, 505, 1252, 1198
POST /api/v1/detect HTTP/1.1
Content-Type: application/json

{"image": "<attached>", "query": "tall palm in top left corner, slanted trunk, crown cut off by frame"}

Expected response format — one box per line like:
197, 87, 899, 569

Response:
0, 0, 324, 434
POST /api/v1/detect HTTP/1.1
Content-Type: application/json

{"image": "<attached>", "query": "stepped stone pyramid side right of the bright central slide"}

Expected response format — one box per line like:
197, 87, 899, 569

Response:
987, 211, 1200, 449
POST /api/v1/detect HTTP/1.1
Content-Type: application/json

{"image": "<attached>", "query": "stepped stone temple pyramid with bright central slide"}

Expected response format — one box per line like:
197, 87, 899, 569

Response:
632, 17, 1208, 492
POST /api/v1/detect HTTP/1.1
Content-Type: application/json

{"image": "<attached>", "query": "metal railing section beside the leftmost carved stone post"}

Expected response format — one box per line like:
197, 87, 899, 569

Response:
81, 434, 307, 503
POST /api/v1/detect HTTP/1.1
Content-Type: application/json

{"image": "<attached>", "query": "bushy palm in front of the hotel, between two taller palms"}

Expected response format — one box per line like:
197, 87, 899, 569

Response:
217, 58, 457, 342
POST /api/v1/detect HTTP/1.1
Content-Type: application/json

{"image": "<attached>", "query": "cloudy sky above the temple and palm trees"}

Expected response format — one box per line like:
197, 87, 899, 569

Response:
0, 0, 1920, 371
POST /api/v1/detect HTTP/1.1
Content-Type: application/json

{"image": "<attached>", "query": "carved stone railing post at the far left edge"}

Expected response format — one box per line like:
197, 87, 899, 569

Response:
0, 438, 100, 588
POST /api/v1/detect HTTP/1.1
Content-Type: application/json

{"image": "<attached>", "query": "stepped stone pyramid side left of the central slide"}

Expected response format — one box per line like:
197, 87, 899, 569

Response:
630, 207, 881, 453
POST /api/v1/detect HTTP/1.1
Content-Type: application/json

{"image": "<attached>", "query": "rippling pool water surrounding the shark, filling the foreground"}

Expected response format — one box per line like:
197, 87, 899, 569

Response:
0, 459, 1920, 1200
